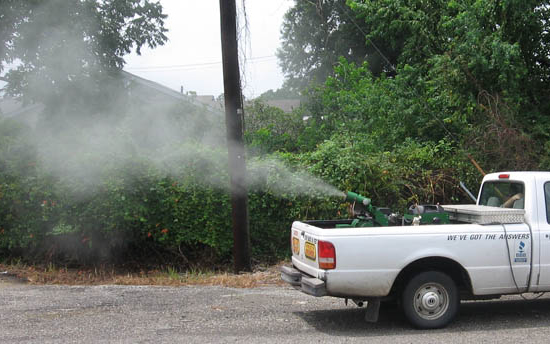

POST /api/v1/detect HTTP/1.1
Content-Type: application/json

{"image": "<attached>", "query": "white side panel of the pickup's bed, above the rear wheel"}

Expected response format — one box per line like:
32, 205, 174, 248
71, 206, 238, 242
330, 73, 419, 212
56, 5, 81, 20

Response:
292, 222, 532, 297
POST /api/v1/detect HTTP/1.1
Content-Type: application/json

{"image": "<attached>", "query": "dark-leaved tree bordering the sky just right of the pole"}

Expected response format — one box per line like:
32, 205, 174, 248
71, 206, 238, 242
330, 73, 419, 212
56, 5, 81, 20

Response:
277, 0, 399, 89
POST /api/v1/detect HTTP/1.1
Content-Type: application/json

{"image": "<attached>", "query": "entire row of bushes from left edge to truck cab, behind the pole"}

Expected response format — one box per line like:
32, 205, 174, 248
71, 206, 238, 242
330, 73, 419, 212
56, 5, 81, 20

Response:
0, 118, 479, 266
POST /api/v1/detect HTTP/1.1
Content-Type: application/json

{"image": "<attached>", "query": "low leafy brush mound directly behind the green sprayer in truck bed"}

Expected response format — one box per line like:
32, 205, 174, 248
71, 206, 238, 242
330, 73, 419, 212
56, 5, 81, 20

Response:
303, 134, 480, 212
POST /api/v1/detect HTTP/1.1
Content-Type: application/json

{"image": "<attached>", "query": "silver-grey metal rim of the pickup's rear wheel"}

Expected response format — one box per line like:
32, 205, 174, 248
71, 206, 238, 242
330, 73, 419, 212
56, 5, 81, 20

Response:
414, 282, 449, 320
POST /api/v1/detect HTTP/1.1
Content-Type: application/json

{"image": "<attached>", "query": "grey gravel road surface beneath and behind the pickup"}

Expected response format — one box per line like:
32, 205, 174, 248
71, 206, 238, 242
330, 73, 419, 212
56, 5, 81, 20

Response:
0, 281, 550, 344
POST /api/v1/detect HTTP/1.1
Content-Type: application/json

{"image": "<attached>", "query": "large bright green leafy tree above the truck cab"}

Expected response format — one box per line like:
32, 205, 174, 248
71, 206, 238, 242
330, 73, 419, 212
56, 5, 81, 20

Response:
349, 0, 550, 169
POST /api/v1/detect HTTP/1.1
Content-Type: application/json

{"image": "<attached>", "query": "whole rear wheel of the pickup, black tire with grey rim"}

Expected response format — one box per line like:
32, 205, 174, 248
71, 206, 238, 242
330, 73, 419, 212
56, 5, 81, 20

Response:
401, 271, 460, 329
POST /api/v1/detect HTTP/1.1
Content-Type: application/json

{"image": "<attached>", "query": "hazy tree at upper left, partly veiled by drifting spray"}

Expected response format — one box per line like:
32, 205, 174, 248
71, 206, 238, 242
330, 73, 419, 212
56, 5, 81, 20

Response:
0, 0, 167, 103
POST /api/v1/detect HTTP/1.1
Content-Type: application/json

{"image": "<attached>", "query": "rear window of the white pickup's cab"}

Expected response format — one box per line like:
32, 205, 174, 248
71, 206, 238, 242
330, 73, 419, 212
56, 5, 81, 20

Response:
479, 181, 525, 209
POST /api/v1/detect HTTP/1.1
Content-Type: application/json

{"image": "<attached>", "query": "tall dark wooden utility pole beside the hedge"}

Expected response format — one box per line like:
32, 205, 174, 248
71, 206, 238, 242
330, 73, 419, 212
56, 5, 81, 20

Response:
220, 0, 252, 273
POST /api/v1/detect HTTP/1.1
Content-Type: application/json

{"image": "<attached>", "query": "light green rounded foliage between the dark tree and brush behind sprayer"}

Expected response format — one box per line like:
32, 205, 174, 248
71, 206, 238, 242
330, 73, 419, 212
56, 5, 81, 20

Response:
307, 59, 466, 149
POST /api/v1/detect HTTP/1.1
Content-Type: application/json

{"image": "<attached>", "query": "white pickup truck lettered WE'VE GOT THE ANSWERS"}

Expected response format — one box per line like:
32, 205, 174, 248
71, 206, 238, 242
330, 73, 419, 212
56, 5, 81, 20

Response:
282, 172, 550, 328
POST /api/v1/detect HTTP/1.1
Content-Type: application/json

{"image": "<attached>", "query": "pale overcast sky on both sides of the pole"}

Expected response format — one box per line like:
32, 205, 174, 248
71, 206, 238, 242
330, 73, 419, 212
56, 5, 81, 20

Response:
124, 0, 293, 99
